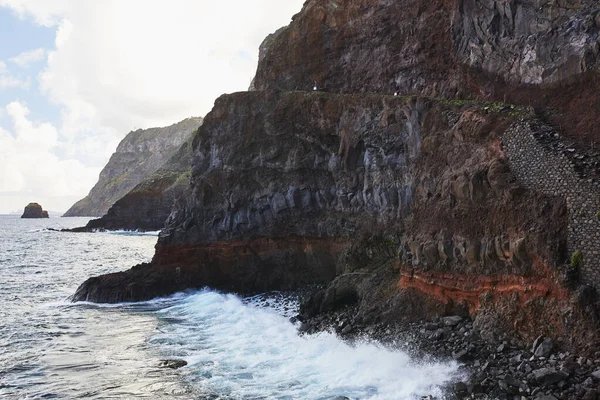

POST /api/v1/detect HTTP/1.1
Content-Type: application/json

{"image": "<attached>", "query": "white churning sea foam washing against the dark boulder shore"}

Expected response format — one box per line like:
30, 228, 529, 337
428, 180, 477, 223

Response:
150, 291, 457, 400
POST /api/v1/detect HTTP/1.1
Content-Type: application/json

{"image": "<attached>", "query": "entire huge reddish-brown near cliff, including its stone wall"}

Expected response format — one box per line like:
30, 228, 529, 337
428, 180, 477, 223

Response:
74, 0, 600, 354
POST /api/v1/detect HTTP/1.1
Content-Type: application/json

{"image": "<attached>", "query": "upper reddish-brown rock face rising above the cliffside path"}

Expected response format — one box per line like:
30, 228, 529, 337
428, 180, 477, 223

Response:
254, 0, 600, 140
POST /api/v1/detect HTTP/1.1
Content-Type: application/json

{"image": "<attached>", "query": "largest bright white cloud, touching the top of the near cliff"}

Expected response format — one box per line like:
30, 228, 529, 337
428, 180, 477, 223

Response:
0, 0, 303, 209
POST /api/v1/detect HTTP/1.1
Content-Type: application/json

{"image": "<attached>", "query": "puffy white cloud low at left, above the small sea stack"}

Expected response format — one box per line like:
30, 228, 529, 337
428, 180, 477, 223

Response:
0, 102, 100, 212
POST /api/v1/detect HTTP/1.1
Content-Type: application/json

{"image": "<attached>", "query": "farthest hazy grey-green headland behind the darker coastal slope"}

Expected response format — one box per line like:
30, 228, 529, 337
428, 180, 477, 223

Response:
64, 118, 202, 217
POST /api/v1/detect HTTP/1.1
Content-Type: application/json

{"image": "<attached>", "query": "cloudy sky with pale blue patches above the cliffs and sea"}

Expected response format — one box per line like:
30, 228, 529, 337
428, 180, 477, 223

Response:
0, 0, 303, 214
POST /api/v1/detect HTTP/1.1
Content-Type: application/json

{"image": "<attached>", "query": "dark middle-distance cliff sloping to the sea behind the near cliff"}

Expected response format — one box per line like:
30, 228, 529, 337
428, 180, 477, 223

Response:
69, 135, 194, 232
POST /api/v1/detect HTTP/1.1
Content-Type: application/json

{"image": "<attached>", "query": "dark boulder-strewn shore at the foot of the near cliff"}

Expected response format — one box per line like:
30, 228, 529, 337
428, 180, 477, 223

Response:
292, 306, 600, 400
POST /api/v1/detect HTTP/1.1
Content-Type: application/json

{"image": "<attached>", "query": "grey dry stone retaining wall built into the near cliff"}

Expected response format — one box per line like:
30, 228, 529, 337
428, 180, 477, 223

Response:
503, 120, 600, 282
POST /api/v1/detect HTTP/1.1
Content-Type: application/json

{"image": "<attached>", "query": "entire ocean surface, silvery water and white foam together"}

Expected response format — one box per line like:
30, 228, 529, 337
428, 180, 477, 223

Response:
0, 216, 457, 400
